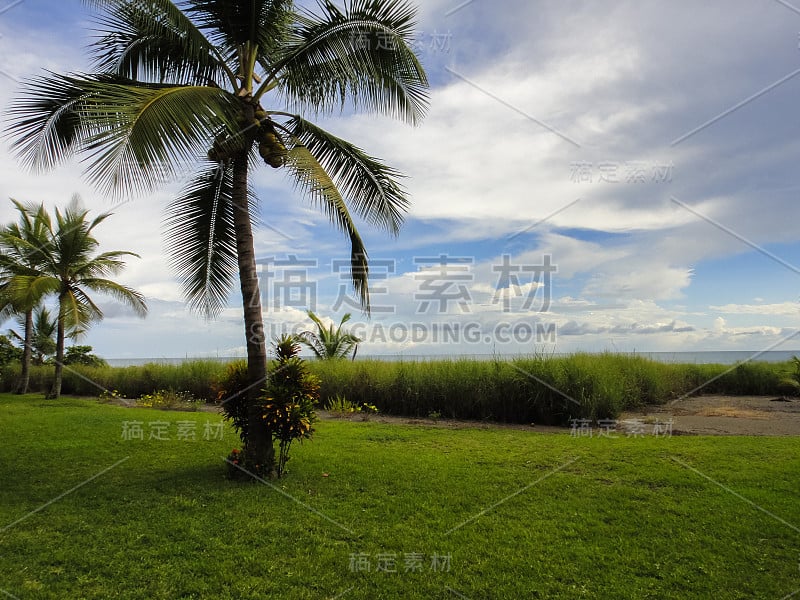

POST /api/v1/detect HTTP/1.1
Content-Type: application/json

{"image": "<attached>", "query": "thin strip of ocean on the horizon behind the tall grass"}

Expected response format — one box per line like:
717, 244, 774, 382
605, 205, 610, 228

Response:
106, 350, 800, 367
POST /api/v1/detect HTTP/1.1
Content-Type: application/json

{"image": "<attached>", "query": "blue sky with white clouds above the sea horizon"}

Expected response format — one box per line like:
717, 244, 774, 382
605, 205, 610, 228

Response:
0, 0, 800, 358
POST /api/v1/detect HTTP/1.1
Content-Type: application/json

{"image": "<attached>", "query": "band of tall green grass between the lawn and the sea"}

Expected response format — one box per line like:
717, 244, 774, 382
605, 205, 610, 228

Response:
0, 353, 793, 425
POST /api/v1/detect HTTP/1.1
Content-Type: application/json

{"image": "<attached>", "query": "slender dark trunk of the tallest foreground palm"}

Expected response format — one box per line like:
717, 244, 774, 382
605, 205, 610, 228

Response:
233, 152, 275, 471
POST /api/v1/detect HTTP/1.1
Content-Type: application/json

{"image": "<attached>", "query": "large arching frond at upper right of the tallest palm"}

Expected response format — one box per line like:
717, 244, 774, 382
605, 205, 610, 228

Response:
268, 0, 428, 123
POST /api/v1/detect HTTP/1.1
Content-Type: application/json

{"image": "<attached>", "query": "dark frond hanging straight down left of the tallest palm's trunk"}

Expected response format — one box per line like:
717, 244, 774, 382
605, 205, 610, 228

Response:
165, 159, 238, 317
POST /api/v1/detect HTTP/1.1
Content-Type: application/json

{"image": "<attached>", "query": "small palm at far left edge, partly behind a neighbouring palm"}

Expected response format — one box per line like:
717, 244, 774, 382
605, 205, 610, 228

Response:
0, 200, 52, 394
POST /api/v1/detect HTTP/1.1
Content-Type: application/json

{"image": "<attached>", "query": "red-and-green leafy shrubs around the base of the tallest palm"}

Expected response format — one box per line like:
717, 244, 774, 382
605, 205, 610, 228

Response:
218, 336, 320, 479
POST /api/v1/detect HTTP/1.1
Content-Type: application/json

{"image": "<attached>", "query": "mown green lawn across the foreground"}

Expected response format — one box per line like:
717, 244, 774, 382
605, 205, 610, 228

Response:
0, 395, 800, 600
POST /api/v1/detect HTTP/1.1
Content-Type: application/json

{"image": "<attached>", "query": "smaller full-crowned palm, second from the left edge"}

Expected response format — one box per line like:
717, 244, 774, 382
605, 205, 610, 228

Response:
10, 198, 147, 398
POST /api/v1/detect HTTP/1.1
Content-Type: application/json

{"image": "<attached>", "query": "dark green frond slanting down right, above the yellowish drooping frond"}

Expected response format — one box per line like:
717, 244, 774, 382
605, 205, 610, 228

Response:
287, 116, 410, 235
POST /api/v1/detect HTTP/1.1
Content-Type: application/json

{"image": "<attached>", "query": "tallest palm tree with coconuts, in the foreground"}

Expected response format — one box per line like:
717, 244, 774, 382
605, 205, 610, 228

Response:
4, 0, 428, 464
